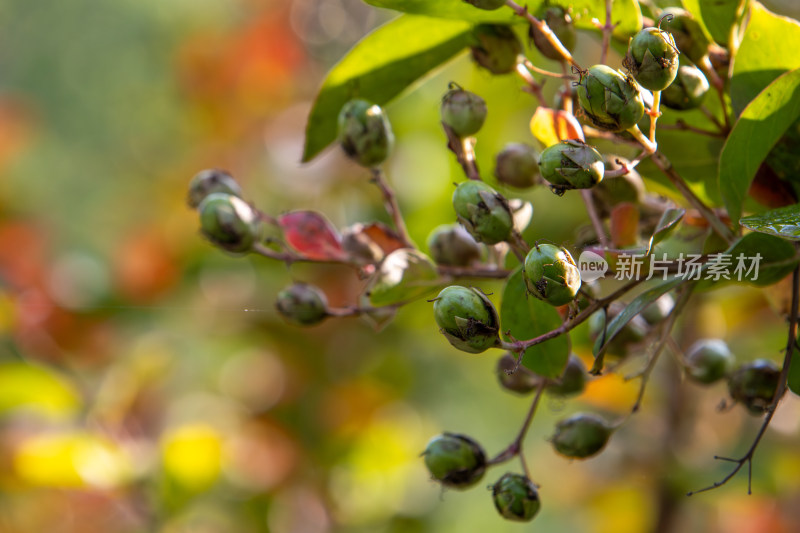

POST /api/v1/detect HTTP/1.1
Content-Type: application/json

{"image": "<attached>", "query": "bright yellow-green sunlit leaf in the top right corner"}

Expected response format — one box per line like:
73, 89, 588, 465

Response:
728, 2, 800, 115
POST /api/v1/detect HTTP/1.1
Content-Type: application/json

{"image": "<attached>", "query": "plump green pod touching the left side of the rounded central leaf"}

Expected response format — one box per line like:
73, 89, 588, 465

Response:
433, 285, 500, 353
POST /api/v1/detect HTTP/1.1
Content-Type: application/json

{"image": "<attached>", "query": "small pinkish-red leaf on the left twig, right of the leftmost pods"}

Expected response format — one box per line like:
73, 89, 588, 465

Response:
278, 211, 347, 261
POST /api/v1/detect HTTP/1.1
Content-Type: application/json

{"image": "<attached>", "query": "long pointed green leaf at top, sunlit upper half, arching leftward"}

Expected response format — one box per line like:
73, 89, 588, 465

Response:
303, 15, 472, 162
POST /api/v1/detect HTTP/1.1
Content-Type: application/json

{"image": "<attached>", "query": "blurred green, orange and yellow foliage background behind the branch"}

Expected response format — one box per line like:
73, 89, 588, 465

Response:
0, 0, 800, 533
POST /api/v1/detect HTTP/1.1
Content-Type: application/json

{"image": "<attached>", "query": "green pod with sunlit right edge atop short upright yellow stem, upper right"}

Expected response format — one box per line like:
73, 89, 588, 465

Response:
622, 27, 680, 91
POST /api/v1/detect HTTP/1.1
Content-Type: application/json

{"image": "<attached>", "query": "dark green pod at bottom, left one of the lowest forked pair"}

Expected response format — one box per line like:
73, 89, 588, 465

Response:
422, 433, 486, 490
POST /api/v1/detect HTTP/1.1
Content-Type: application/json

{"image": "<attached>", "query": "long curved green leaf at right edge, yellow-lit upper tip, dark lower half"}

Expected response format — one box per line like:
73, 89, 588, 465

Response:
719, 69, 800, 223
